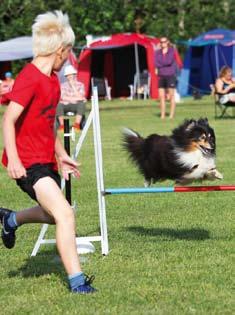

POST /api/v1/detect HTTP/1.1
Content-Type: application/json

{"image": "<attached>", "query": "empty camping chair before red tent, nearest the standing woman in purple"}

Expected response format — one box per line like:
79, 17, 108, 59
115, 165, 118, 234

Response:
129, 70, 150, 100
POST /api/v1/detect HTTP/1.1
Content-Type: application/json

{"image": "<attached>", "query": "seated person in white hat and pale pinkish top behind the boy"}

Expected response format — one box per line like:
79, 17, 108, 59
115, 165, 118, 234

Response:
56, 65, 86, 131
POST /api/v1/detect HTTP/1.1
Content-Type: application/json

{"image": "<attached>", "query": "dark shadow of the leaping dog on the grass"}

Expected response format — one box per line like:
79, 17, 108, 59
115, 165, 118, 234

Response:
127, 226, 210, 241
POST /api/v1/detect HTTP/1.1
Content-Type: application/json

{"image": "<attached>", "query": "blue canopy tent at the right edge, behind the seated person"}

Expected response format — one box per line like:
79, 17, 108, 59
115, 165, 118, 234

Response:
178, 29, 235, 96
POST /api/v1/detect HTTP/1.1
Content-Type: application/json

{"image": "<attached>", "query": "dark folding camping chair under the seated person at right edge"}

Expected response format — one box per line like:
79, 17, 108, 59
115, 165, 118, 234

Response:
210, 84, 235, 118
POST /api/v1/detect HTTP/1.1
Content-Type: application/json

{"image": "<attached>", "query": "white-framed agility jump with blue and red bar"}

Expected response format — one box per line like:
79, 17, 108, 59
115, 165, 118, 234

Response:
31, 87, 235, 256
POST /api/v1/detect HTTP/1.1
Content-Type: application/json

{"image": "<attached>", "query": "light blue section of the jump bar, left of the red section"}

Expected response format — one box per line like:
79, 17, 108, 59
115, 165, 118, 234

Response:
104, 187, 174, 195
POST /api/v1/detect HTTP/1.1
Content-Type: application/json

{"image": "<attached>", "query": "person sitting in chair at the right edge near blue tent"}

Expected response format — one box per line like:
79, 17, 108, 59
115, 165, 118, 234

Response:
215, 66, 235, 105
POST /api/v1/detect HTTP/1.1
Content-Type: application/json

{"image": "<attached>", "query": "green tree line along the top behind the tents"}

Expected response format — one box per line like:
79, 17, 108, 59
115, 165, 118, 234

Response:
0, 0, 235, 46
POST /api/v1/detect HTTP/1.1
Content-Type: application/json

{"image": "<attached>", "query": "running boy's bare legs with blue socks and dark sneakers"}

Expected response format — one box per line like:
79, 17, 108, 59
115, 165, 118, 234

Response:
0, 176, 96, 294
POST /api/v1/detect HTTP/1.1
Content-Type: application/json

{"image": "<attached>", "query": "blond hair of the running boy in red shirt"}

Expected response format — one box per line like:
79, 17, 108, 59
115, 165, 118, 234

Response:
32, 11, 75, 57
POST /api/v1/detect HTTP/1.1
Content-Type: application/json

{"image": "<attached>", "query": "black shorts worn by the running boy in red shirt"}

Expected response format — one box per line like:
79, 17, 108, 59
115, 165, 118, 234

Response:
16, 164, 61, 201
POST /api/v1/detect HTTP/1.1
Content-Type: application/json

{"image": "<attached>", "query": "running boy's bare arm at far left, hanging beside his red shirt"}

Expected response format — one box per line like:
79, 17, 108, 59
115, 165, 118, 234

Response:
2, 102, 26, 179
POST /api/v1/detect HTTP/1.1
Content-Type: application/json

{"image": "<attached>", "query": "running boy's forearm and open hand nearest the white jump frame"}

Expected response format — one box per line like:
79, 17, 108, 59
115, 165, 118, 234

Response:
55, 135, 80, 180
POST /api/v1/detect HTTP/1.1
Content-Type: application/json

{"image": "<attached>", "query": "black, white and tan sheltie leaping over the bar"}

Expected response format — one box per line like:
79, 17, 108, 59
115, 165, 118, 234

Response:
123, 118, 223, 186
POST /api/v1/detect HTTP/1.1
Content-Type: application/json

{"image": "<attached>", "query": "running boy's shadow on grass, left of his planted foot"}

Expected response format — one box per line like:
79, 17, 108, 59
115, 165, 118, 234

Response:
8, 250, 66, 282
